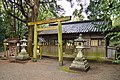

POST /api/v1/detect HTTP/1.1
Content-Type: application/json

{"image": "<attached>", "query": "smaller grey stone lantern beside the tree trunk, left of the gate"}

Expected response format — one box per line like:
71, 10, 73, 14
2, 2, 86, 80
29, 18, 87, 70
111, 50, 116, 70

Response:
17, 37, 30, 60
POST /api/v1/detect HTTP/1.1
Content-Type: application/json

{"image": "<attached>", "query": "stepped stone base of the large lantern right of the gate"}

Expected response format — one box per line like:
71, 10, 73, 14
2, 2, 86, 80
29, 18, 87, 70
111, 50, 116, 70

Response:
69, 57, 90, 71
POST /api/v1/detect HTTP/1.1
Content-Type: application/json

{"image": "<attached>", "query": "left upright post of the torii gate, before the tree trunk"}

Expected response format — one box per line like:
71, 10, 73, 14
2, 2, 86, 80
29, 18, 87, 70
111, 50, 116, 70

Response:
33, 24, 37, 62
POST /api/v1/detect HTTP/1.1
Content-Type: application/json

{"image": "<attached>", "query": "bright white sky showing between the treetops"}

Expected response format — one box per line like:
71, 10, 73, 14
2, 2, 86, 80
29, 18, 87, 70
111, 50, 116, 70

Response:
57, 0, 90, 20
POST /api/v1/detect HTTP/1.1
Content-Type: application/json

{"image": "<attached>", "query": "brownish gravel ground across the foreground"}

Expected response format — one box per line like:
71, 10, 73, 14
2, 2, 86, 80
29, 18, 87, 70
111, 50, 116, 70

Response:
0, 58, 120, 80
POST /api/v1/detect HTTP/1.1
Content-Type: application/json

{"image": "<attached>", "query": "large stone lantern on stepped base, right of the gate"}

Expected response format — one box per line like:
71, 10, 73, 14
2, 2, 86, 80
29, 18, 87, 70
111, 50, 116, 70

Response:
69, 34, 90, 71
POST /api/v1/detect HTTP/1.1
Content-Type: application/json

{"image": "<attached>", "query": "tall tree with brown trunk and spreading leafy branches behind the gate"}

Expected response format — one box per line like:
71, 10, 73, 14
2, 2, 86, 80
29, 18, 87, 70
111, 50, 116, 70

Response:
2, 0, 65, 56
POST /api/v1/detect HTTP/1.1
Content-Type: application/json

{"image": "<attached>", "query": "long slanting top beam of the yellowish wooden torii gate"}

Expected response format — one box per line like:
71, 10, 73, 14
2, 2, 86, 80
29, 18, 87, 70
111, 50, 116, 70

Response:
28, 16, 71, 26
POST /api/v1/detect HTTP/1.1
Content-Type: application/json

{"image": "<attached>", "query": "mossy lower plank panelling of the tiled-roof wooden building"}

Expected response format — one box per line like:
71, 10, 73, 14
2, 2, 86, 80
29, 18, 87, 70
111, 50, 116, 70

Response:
43, 46, 106, 58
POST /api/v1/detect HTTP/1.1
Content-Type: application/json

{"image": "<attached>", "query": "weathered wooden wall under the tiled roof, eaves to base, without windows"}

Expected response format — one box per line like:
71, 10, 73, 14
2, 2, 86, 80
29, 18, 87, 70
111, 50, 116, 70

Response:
39, 33, 106, 58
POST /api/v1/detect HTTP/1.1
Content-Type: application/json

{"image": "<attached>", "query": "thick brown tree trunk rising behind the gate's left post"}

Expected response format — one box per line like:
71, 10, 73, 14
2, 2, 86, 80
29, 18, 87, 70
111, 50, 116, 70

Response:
27, 0, 39, 56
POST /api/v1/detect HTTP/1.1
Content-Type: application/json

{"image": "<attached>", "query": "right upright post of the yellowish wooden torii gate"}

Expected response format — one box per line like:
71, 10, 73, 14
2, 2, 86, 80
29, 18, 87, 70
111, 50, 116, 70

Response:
58, 21, 63, 66
